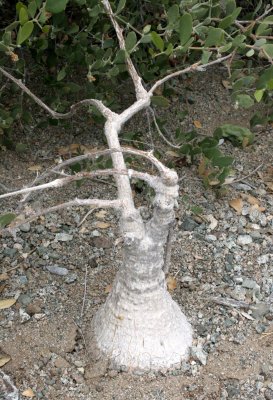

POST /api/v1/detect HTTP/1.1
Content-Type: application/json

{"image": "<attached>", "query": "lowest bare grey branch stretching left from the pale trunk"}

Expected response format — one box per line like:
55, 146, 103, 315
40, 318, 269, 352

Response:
0, 198, 122, 232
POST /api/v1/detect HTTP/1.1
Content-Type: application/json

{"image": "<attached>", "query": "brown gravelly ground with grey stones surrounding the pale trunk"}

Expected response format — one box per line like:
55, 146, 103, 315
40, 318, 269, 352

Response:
0, 70, 273, 400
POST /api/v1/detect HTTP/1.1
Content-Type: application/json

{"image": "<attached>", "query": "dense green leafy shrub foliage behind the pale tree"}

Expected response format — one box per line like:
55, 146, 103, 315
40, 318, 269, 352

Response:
0, 0, 273, 184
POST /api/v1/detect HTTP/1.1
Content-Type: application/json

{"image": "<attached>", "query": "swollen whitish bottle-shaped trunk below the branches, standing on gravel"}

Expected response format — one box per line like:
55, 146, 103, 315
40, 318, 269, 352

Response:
93, 235, 192, 371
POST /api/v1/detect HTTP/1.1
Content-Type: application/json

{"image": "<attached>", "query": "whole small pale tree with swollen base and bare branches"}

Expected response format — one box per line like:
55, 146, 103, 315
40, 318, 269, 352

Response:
0, 0, 271, 371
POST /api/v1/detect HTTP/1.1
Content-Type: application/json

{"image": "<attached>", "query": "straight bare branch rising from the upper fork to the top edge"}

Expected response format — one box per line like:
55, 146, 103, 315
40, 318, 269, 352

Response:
102, 0, 147, 99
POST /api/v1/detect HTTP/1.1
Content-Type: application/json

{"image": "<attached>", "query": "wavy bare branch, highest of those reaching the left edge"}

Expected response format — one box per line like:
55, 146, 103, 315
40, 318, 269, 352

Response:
0, 67, 114, 119
